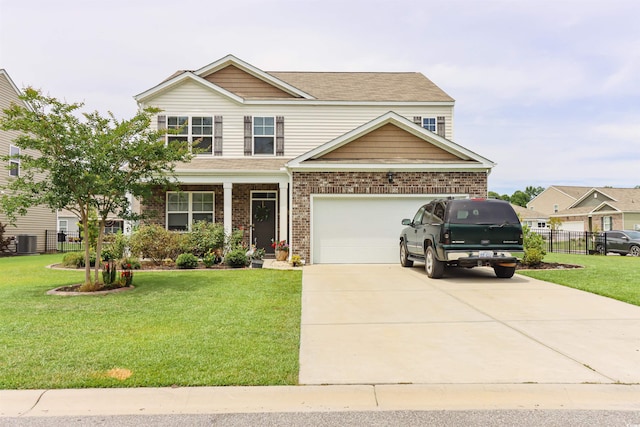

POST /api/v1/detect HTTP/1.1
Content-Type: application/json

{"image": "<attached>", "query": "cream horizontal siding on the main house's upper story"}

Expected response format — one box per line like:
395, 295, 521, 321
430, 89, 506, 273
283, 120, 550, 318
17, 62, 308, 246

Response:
145, 82, 453, 158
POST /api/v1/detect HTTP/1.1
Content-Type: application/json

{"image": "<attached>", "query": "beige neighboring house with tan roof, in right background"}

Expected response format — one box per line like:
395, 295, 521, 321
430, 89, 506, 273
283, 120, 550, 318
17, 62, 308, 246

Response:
551, 187, 640, 231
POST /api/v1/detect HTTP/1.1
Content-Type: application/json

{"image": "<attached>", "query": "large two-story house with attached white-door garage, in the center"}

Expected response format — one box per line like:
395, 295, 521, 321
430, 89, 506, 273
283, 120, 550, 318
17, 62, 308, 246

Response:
135, 55, 494, 263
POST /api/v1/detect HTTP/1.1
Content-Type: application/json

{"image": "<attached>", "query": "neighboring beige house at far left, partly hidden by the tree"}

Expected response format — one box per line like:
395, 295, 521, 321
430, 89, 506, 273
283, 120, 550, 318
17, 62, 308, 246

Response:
0, 69, 56, 252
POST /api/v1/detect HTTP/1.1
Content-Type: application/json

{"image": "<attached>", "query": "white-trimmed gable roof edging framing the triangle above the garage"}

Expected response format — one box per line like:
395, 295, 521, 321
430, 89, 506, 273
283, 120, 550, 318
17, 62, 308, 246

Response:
287, 111, 495, 170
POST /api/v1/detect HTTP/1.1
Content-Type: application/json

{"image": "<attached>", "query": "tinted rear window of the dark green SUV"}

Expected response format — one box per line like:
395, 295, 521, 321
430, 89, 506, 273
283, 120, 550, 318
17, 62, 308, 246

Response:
448, 200, 520, 224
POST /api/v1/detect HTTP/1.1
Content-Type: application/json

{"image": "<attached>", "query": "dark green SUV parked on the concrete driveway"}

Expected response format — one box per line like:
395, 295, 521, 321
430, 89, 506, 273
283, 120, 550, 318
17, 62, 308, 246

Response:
400, 199, 523, 279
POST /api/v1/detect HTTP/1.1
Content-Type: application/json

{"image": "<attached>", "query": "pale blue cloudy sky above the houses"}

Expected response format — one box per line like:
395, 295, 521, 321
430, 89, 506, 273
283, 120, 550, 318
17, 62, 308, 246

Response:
0, 0, 640, 195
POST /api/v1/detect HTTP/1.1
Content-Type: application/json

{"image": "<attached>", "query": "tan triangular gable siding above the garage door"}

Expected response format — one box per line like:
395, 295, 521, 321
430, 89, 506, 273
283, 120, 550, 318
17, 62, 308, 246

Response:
322, 124, 458, 160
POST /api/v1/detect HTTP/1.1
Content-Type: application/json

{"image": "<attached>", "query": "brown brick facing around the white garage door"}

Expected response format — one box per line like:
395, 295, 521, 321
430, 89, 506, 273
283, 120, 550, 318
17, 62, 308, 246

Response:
290, 171, 487, 261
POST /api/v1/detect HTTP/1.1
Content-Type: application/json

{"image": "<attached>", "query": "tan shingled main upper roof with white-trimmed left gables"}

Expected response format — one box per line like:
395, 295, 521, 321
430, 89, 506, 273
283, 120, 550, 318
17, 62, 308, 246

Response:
134, 55, 454, 104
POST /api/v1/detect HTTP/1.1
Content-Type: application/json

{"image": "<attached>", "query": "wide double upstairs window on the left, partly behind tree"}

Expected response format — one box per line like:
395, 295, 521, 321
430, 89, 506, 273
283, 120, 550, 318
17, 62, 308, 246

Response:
167, 116, 213, 155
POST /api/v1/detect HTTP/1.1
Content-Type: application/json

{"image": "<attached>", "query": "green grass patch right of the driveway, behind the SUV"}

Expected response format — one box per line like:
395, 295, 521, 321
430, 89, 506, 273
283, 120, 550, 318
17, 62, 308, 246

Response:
518, 253, 640, 306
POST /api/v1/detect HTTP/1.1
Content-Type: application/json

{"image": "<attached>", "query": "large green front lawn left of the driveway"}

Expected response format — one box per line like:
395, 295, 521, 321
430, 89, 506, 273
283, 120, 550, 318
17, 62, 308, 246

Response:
0, 255, 302, 389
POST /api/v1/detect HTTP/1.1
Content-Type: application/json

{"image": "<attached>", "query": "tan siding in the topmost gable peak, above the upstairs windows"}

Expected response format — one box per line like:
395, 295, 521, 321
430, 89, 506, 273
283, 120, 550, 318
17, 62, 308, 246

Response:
205, 65, 293, 99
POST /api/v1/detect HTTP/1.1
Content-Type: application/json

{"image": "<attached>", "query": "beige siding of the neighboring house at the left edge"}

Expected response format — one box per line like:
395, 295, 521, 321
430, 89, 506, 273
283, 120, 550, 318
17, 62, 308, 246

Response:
0, 72, 57, 252
